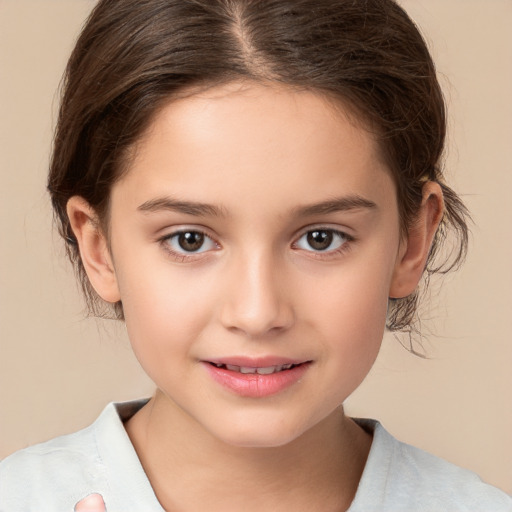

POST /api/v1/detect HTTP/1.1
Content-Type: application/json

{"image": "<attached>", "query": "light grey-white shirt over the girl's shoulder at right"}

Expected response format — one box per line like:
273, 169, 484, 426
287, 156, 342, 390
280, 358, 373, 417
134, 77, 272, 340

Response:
350, 420, 512, 512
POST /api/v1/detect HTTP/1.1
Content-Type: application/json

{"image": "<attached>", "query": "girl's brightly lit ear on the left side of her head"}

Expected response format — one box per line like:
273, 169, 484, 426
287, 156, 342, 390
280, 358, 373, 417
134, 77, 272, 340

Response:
66, 196, 121, 303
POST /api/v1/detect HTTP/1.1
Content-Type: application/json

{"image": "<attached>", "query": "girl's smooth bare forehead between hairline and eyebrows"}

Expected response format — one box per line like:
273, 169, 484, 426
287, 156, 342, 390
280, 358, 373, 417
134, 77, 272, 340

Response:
113, 83, 389, 216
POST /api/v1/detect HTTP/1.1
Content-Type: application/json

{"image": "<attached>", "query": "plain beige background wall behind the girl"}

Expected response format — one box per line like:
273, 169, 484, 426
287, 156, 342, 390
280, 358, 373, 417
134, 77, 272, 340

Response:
0, 0, 512, 492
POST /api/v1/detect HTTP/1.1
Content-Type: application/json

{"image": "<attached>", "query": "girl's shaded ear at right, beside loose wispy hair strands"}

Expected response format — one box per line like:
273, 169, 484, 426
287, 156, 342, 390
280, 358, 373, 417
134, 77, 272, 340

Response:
389, 181, 444, 299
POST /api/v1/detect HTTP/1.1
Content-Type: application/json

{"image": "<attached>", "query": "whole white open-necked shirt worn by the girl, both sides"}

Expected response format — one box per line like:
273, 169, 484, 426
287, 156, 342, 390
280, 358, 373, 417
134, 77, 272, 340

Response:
0, 400, 512, 512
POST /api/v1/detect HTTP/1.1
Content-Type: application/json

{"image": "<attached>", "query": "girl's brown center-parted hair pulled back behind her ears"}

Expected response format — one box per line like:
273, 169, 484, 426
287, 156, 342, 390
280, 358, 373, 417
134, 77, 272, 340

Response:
48, 0, 468, 330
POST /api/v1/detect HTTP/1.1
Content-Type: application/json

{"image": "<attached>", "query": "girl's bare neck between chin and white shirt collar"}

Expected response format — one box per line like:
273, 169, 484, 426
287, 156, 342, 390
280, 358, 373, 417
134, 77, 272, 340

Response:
126, 391, 371, 512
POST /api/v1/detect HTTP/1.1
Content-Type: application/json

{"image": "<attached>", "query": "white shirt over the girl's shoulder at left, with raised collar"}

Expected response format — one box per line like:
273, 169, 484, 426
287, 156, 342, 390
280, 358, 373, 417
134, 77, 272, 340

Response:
0, 400, 163, 512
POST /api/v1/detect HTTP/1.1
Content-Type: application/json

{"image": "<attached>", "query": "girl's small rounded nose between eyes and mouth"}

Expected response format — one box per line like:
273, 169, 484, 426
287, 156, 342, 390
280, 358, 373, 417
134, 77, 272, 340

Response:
221, 249, 294, 338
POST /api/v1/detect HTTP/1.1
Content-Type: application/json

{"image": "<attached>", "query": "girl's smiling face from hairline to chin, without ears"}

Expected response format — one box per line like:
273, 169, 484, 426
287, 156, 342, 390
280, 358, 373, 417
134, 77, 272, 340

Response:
86, 84, 418, 446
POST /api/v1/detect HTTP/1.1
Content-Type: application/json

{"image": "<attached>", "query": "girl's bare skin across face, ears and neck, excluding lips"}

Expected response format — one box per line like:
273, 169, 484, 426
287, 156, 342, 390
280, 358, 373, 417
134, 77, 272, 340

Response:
68, 83, 443, 511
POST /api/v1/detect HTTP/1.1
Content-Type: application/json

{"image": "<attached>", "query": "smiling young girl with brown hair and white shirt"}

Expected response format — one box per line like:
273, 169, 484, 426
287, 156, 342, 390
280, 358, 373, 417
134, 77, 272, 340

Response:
0, 0, 512, 512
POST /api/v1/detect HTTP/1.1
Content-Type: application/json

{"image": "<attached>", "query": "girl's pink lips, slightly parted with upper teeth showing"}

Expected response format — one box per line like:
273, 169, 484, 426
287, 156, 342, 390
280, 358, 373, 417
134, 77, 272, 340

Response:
202, 358, 311, 398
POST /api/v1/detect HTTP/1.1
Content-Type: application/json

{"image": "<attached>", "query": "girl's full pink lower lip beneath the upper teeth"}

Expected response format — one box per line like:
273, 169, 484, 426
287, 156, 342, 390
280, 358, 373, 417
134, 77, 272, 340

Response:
203, 363, 311, 398
